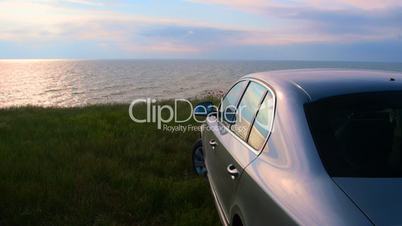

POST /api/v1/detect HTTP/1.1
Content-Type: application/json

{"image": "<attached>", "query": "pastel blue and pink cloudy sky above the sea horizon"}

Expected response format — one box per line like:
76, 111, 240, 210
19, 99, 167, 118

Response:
0, 0, 402, 62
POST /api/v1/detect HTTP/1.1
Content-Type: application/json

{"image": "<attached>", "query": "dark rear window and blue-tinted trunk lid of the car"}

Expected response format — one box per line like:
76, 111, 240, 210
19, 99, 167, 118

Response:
305, 90, 402, 225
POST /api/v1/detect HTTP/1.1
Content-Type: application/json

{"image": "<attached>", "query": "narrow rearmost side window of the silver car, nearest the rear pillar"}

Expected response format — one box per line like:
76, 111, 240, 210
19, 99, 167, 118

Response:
248, 92, 275, 150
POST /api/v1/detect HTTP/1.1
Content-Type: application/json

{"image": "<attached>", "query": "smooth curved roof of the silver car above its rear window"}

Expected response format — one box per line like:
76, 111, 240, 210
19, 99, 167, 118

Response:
245, 69, 402, 101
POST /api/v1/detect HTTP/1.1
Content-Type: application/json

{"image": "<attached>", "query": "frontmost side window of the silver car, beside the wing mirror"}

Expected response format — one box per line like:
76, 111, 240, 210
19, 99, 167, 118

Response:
219, 81, 248, 126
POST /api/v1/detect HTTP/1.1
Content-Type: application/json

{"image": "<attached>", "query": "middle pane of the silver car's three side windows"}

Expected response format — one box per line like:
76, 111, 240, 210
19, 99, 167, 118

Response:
230, 82, 267, 141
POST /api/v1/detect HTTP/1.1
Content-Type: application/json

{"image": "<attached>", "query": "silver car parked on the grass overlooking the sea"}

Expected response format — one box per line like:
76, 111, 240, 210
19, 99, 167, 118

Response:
193, 69, 402, 226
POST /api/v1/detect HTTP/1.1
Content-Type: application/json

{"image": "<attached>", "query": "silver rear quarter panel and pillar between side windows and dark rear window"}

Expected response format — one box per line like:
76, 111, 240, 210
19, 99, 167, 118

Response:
236, 78, 370, 225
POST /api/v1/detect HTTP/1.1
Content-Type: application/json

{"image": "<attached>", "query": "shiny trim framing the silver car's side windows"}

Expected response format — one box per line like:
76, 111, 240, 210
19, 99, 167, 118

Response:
217, 78, 277, 155
